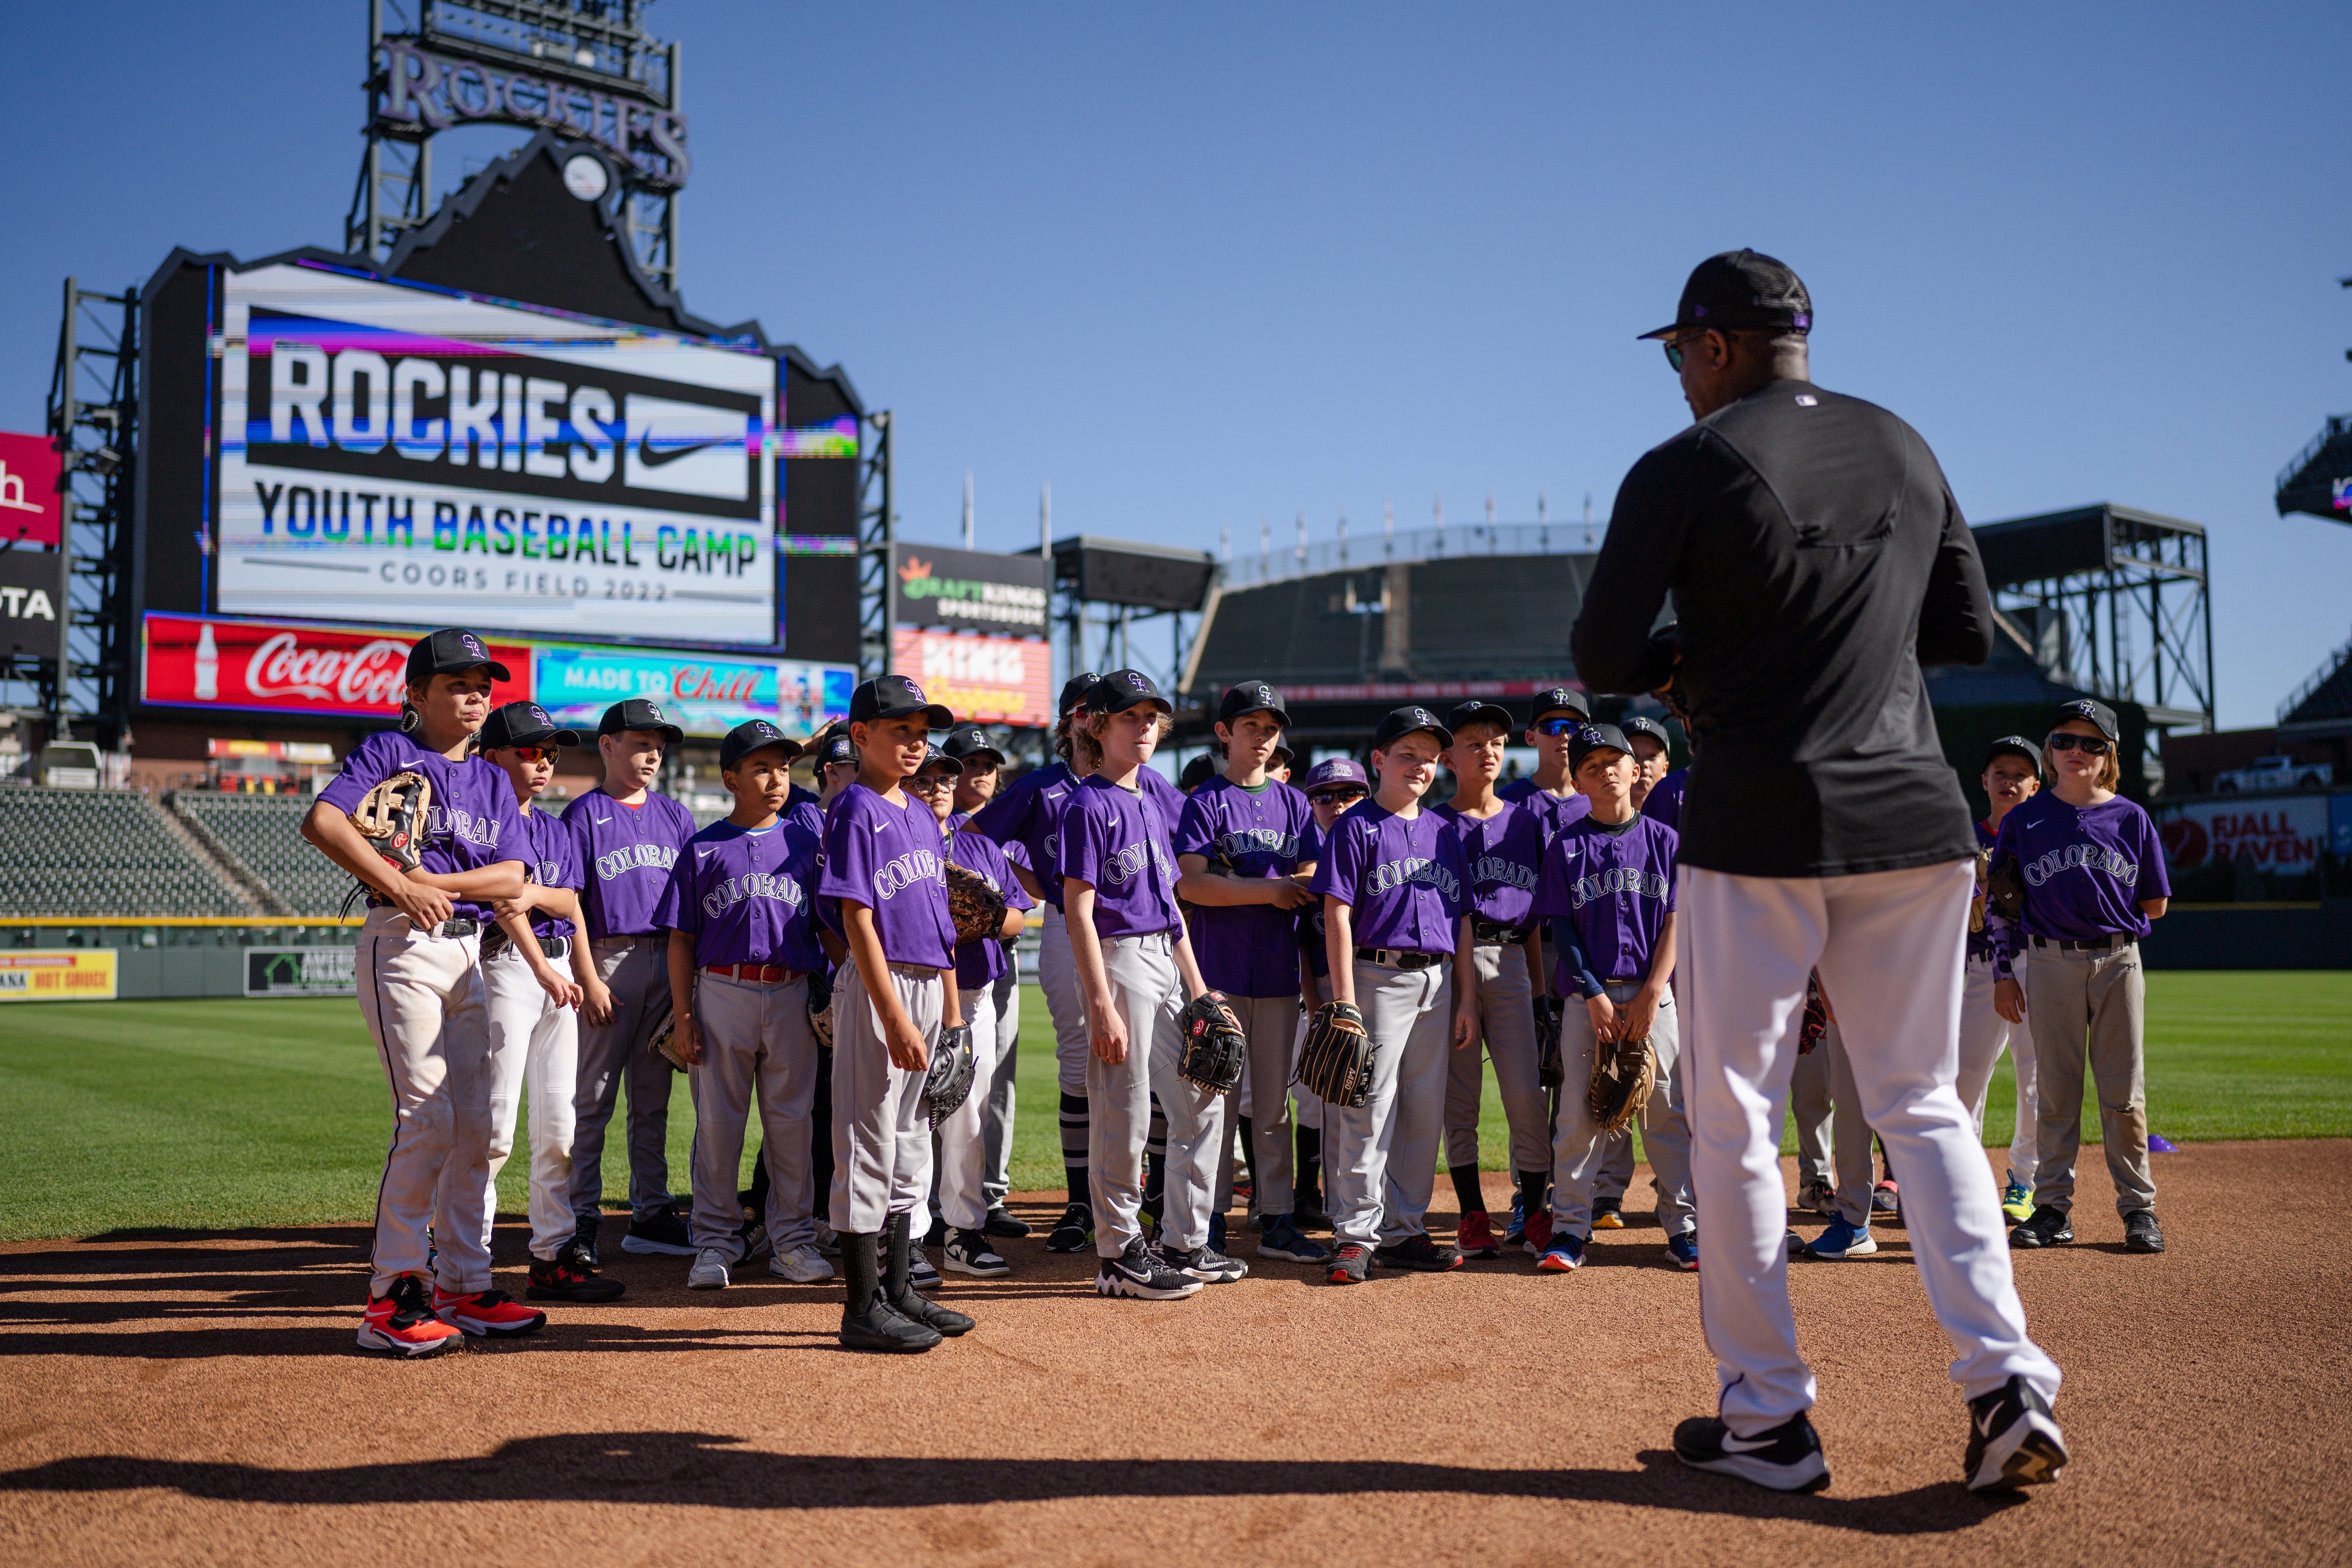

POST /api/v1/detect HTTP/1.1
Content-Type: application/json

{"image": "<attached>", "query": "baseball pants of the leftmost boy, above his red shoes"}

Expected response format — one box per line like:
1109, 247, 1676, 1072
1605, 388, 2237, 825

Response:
358, 907, 492, 1295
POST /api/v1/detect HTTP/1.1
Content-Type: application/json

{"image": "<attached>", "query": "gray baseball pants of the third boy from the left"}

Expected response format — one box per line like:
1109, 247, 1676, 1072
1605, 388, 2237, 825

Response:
571, 931, 672, 1222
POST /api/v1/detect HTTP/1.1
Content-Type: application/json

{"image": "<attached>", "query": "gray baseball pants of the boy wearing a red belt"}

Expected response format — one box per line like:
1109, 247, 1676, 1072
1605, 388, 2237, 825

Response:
687, 971, 818, 1263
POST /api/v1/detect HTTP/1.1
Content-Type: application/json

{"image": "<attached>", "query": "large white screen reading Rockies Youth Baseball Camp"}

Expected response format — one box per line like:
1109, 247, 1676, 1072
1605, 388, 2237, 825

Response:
216, 266, 779, 644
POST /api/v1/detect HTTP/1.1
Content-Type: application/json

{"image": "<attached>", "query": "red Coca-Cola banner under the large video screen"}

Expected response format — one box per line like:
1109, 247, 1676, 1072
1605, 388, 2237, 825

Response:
139, 614, 532, 719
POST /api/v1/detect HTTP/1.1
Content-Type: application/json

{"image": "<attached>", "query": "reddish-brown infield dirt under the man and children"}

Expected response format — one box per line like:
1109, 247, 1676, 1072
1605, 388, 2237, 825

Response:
0, 1143, 2352, 1568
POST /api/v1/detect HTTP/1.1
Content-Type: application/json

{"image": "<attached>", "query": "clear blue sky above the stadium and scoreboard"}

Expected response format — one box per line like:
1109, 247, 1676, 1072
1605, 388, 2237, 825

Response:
0, 0, 2352, 726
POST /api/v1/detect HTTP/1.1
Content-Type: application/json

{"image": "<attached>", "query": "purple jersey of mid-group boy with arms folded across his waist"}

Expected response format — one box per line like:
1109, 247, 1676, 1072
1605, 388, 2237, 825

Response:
1176, 776, 1315, 997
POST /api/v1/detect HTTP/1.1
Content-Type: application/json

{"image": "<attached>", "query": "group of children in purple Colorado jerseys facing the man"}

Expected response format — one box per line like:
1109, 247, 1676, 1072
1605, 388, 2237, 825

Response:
303, 630, 2166, 1354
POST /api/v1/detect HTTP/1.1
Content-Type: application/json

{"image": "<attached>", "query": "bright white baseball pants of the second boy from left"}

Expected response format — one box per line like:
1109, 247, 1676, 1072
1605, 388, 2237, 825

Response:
482, 947, 581, 1260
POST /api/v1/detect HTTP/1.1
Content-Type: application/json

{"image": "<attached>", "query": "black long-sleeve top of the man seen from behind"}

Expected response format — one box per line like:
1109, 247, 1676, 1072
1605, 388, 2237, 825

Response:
1569, 381, 1992, 877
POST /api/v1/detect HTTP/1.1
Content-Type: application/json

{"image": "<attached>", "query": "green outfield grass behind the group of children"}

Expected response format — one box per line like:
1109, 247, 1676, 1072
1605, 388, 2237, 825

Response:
0, 971, 2352, 1239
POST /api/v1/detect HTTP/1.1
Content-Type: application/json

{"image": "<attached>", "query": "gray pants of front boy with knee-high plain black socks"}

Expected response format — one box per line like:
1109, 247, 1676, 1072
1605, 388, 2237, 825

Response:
830, 954, 948, 1237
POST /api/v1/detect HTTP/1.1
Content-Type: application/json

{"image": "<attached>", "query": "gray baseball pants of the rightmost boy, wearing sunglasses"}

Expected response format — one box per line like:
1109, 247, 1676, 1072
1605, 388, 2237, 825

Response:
2025, 943, 2157, 1218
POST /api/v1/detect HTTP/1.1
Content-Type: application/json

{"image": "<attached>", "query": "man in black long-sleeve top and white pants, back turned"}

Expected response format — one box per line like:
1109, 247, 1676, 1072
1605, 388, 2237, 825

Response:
1571, 251, 2065, 1490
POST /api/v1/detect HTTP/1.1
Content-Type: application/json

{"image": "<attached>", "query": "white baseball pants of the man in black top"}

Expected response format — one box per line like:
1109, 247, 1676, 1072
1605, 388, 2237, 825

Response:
1674, 861, 2058, 1437
